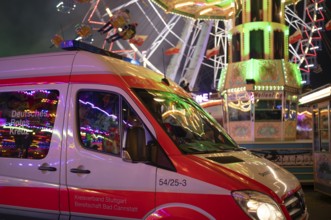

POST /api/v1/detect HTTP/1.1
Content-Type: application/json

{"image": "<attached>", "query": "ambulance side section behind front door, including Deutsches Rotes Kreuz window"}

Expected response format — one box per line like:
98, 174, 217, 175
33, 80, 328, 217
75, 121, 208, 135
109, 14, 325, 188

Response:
0, 84, 67, 219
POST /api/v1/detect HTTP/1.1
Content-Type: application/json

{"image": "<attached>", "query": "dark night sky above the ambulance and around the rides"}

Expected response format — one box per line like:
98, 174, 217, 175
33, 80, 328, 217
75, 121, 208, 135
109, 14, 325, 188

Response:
0, 0, 331, 88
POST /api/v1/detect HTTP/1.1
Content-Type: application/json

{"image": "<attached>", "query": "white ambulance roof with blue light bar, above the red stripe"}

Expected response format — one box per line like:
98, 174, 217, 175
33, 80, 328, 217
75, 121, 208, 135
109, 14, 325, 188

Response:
0, 41, 189, 97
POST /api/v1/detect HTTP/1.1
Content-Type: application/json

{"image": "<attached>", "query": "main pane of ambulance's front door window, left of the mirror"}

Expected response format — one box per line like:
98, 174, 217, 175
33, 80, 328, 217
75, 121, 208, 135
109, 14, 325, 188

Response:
77, 91, 120, 155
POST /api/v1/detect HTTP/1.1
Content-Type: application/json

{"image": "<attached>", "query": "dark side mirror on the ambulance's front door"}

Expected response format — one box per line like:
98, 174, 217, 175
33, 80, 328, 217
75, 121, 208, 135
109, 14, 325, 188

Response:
122, 127, 147, 162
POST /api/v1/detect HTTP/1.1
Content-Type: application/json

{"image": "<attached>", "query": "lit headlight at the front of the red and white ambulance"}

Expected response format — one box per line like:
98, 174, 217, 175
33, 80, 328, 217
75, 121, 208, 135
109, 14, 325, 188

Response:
232, 191, 285, 220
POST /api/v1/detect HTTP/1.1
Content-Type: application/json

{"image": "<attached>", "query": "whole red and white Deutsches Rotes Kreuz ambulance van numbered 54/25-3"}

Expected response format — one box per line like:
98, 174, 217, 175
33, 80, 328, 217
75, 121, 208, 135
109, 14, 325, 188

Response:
0, 41, 308, 220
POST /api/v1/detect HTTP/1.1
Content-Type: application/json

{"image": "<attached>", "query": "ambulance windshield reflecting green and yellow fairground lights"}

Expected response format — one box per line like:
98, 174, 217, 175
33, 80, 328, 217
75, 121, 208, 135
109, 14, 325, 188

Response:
134, 89, 241, 154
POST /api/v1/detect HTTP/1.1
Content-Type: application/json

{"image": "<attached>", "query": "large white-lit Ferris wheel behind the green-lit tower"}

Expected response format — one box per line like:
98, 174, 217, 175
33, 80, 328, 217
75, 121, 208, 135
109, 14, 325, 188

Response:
53, 0, 325, 92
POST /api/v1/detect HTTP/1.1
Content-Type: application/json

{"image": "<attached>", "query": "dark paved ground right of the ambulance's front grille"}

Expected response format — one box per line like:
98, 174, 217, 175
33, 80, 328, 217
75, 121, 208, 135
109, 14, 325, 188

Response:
303, 185, 331, 220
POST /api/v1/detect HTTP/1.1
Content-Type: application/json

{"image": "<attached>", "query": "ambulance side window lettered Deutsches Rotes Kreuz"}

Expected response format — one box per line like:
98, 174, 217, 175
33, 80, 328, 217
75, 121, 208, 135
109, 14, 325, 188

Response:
0, 90, 59, 159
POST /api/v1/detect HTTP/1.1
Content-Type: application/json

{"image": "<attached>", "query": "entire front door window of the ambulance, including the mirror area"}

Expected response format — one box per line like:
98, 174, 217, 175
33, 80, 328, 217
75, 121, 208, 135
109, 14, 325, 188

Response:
77, 90, 174, 170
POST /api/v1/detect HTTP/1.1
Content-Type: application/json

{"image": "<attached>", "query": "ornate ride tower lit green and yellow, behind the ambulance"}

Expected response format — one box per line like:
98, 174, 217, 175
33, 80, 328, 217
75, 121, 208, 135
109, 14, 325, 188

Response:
219, 0, 301, 141
